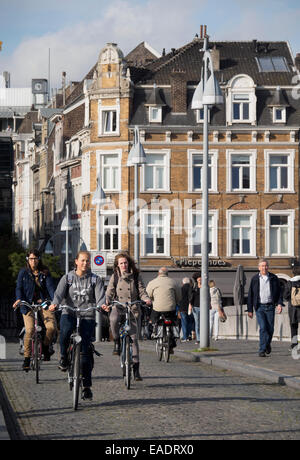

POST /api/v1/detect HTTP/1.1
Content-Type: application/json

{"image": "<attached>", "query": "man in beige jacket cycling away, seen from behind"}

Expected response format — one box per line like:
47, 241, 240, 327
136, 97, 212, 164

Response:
146, 267, 181, 353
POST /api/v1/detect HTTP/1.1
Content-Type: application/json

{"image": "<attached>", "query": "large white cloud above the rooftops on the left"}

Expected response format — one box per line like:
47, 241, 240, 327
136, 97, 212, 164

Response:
0, 0, 205, 87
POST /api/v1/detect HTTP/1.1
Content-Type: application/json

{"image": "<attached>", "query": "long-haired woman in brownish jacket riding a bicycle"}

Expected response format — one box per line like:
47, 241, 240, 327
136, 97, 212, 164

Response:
105, 252, 151, 381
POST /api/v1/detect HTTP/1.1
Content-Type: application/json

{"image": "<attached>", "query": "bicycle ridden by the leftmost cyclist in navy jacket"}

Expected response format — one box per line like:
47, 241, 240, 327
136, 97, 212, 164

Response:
18, 300, 49, 383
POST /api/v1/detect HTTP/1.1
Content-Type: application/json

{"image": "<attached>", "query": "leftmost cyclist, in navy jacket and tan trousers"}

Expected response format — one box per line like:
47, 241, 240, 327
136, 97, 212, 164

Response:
13, 249, 57, 370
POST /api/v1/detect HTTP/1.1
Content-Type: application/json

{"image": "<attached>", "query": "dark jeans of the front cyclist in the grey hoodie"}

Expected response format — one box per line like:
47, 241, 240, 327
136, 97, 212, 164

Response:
60, 315, 95, 388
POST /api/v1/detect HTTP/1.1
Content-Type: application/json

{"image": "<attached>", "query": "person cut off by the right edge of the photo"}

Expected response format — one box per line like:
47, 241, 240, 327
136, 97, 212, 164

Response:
283, 265, 300, 349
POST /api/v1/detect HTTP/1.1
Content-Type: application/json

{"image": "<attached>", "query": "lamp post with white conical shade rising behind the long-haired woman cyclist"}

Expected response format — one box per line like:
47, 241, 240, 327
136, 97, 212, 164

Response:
127, 126, 147, 268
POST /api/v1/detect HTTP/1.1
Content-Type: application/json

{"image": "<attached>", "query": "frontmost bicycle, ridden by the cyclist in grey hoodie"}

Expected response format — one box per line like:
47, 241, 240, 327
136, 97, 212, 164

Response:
58, 305, 101, 410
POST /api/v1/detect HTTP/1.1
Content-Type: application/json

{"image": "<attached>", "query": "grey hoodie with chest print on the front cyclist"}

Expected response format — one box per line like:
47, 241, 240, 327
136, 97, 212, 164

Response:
53, 270, 105, 319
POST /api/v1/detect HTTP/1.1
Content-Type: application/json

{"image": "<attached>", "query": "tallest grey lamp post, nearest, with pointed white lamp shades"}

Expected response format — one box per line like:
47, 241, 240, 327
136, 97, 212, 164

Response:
192, 37, 223, 348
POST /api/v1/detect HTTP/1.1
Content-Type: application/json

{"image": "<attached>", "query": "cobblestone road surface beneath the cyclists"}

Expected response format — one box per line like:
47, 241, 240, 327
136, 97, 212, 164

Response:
0, 343, 300, 441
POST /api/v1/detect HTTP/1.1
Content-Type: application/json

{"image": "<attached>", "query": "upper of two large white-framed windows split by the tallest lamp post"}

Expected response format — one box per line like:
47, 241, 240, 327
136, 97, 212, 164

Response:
188, 150, 218, 192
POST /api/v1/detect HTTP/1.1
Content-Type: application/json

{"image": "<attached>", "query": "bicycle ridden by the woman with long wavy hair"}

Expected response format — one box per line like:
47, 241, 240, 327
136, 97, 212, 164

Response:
112, 300, 145, 390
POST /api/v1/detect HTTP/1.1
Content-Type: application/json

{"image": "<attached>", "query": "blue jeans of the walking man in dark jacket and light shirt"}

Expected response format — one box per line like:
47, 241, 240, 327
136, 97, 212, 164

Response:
256, 304, 275, 353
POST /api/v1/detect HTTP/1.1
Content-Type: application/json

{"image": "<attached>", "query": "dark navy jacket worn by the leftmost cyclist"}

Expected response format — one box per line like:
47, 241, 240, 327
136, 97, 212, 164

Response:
16, 268, 55, 315
